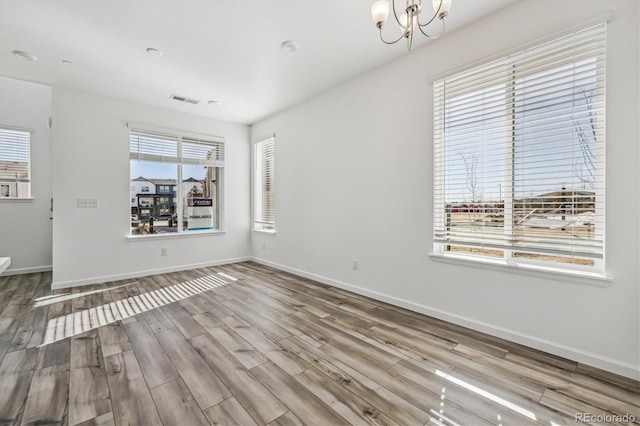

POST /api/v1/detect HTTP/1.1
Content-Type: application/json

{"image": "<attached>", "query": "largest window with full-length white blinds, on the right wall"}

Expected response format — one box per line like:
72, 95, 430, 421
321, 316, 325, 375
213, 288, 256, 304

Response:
434, 23, 606, 271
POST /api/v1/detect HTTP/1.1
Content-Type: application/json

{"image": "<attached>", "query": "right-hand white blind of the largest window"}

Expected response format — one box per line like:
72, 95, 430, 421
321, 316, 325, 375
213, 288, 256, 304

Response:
513, 24, 606, 258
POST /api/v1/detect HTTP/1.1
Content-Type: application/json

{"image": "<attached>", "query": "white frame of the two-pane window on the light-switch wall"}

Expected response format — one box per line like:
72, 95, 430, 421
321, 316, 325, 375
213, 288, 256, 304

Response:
127, 123, 226, 241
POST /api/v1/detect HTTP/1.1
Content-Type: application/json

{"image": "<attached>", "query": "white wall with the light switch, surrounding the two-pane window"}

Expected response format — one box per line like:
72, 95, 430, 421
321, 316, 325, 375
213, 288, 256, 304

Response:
52, 86, 250, 288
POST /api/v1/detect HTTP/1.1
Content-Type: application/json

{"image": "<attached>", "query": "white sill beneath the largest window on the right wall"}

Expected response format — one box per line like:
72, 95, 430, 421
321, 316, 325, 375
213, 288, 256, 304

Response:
429, 253, 613, 287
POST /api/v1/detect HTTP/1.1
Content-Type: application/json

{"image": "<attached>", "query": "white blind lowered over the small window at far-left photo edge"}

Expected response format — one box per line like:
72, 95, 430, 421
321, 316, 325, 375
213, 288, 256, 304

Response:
0, 128, 31, 183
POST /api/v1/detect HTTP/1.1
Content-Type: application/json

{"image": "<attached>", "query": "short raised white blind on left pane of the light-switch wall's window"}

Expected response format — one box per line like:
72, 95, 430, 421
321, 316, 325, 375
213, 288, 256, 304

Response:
129, 129, 179, 163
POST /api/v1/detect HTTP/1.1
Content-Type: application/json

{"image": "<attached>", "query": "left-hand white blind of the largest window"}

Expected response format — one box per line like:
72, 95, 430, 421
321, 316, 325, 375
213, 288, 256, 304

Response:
434, 60, 512, 248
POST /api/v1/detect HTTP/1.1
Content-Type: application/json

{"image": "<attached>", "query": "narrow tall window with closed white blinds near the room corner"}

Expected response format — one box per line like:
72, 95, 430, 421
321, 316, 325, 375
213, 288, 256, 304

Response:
253, 138, 276, 232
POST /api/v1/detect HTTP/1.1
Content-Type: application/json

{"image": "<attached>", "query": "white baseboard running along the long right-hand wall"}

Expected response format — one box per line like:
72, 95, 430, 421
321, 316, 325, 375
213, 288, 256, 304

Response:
251, 257, 640, 380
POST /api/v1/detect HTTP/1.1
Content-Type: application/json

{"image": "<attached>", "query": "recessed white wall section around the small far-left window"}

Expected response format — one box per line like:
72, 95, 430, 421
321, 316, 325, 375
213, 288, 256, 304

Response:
0, 77, 52, 274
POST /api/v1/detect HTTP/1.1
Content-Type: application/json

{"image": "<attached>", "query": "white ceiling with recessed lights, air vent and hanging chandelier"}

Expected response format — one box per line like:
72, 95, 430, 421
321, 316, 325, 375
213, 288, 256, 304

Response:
0, 0, 515, 124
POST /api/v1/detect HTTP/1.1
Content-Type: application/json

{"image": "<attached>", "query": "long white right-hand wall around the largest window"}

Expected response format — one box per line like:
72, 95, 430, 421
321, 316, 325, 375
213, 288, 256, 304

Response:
251, 0, 640, 378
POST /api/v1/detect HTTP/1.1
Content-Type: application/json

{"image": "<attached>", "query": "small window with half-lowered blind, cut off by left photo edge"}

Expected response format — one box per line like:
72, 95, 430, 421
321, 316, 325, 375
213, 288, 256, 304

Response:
0, 127, 31, 198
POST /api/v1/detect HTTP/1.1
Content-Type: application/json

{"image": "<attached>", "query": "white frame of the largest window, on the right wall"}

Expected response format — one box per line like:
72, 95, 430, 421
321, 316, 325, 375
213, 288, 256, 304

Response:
430, 20, 609, 280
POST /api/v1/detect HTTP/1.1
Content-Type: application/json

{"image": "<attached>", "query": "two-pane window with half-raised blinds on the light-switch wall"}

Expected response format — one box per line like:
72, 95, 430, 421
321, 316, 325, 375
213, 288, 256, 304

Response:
130, 126, 224, 235
